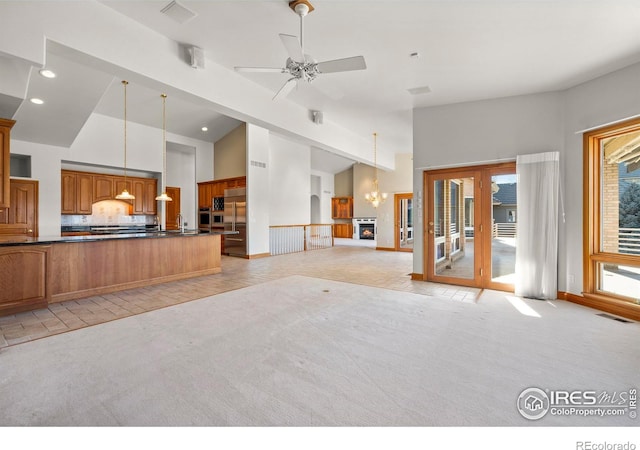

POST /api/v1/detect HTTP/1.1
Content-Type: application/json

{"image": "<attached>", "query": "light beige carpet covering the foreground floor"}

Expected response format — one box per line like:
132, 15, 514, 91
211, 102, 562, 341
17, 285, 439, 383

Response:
0, 276, 640, 426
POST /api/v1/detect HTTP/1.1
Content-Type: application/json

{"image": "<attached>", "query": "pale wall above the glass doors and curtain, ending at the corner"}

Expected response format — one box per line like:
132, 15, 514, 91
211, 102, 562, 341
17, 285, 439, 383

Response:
413, 92, 564, 273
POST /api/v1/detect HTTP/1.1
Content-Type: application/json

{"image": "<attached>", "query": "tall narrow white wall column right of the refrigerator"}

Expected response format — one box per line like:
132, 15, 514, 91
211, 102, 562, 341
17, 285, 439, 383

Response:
247, 124, 271, 256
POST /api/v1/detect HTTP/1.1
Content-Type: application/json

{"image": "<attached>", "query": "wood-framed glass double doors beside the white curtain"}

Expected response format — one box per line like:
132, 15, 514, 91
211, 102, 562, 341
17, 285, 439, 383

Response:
424, 162, 517, 291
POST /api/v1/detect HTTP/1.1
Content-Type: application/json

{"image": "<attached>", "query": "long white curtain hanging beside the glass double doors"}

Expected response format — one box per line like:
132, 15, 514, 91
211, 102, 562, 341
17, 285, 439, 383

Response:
515, 152, 560, 299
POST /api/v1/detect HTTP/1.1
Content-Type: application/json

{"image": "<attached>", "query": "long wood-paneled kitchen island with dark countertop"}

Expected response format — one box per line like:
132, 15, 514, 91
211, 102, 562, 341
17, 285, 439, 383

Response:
0, 231, 234, 316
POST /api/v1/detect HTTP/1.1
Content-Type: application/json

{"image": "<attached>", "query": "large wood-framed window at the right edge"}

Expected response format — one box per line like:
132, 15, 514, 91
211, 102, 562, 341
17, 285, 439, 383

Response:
584, 120, 640, 303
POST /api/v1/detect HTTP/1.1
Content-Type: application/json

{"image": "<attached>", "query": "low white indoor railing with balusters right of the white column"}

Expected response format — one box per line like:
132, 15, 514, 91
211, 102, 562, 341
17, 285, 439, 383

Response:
269, 224, 333, 255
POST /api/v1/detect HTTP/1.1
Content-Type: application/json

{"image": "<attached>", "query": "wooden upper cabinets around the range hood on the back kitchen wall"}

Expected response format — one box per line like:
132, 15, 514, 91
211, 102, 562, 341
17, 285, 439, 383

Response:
61, 170, 158, 215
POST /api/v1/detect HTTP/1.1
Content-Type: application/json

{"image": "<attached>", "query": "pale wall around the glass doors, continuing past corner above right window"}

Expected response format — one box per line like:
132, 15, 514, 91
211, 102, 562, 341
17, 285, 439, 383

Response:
413, 64, 640, 294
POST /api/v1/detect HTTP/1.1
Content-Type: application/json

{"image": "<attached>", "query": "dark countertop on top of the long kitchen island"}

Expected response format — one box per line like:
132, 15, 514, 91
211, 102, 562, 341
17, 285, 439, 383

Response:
0, 230, 238, 247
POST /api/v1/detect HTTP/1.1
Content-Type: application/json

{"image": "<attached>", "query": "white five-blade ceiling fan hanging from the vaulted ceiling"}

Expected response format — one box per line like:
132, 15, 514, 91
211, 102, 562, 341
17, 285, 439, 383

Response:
235, 0, 367, 100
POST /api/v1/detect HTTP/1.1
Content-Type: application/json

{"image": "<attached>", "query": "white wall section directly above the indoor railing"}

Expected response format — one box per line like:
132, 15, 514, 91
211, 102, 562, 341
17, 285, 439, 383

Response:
268, 134, 311, 226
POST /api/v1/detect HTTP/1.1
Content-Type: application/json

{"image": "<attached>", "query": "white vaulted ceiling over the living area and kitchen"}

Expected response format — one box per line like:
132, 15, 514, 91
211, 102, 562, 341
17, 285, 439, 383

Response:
0, 0, 640, 174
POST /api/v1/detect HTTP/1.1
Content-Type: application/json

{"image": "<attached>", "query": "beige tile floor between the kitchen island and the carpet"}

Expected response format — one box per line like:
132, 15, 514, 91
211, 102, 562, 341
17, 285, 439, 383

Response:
0, 246, 481, 348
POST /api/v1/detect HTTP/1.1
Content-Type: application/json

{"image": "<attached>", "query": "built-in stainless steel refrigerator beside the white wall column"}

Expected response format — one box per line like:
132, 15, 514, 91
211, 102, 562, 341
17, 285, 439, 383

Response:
223, 188, 247, 256
